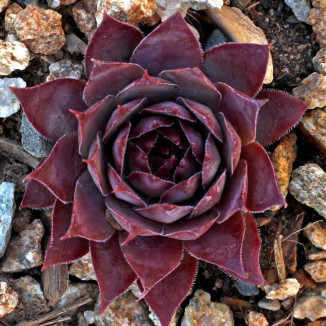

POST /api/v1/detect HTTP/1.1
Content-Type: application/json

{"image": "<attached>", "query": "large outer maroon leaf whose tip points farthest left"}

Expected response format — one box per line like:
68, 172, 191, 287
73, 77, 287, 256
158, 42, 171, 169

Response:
10, 78, 87, 142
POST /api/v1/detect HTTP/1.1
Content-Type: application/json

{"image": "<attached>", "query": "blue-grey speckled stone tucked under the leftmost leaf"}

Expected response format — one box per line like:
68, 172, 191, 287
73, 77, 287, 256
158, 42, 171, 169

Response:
21, 114, 53, 158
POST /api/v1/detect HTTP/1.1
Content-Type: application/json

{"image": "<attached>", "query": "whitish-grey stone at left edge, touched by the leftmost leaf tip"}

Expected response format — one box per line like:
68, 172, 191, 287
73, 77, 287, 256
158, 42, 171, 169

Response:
0, 78, 26, 118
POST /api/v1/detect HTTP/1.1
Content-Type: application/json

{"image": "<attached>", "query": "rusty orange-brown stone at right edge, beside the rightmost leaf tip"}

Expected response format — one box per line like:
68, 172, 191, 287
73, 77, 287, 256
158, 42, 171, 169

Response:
300, 108, 326, 153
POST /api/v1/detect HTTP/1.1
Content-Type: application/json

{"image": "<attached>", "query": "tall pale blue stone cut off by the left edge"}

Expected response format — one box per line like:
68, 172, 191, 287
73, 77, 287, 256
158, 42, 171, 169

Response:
0, 182, 16, 257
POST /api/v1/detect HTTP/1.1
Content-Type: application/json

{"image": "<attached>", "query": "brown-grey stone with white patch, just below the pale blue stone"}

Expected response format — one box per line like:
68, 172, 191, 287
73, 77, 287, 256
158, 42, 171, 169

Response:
1, 219, 44, 273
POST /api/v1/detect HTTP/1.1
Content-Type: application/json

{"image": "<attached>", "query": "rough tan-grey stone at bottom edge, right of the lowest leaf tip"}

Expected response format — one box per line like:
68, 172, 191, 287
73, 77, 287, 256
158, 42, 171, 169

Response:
181, 290, 234, 326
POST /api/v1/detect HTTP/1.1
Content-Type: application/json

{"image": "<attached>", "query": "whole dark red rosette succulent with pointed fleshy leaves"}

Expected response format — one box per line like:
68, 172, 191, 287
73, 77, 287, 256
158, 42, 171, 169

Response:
12, 14, 306, 326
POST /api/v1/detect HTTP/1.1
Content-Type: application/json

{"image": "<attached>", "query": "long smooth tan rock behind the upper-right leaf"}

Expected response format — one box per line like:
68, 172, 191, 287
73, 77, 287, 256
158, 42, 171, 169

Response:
207, 6, 273, 84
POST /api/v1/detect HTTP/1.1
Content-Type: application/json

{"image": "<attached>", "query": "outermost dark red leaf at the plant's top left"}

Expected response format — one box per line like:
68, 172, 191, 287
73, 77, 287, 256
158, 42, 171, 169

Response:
85, 13, 143, 74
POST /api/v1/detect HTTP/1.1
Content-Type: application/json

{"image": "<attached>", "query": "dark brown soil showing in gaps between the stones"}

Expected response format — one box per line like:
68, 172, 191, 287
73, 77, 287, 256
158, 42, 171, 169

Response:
0, 0, 326, 326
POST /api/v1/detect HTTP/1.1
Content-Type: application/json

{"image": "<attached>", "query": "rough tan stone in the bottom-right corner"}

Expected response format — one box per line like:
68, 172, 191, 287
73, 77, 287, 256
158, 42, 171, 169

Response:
293, 285, 326, 321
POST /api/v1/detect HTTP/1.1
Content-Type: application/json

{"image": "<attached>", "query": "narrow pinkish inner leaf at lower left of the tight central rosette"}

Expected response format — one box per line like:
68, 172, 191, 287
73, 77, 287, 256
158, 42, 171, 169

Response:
108, 165, 146, 206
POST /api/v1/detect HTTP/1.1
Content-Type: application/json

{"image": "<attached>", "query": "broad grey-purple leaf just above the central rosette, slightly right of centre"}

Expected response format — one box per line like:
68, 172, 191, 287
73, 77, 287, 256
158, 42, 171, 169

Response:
159, 68, 221, 110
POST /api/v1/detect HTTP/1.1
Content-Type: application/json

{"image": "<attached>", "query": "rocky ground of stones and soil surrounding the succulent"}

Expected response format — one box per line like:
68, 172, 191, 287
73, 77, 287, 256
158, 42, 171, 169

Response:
0, 0, 326, 326
